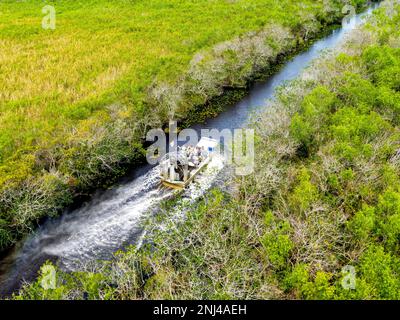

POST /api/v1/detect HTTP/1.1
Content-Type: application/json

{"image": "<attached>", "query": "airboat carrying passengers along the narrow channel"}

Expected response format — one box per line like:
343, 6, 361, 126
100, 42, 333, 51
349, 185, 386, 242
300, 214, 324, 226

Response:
160, 137, 218, 189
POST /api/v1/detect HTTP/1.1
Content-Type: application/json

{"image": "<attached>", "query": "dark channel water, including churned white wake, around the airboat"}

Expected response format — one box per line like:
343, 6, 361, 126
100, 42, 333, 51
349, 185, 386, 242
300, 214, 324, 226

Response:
0, 3, 380, 294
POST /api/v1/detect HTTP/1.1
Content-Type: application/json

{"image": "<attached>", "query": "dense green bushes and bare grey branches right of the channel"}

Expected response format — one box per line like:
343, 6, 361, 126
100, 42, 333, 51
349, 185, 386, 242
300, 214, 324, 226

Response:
15, 0, 400, 299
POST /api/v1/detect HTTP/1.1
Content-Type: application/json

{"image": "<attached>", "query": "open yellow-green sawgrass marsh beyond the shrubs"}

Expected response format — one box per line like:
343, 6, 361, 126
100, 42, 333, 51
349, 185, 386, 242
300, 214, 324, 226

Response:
0, 1, 321, 171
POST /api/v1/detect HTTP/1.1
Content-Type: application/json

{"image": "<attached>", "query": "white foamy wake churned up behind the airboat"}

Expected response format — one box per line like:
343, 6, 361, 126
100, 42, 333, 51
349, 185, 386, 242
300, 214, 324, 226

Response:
12, 168, 171, 270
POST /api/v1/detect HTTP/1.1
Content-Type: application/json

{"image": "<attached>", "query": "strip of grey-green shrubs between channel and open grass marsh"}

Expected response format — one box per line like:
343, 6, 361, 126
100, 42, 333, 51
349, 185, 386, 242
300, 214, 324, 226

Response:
0, 1, 372, 249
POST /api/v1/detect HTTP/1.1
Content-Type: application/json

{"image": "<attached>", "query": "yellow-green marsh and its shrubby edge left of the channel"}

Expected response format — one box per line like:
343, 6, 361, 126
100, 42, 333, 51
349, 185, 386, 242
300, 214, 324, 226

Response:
0, 0, 364, 249
